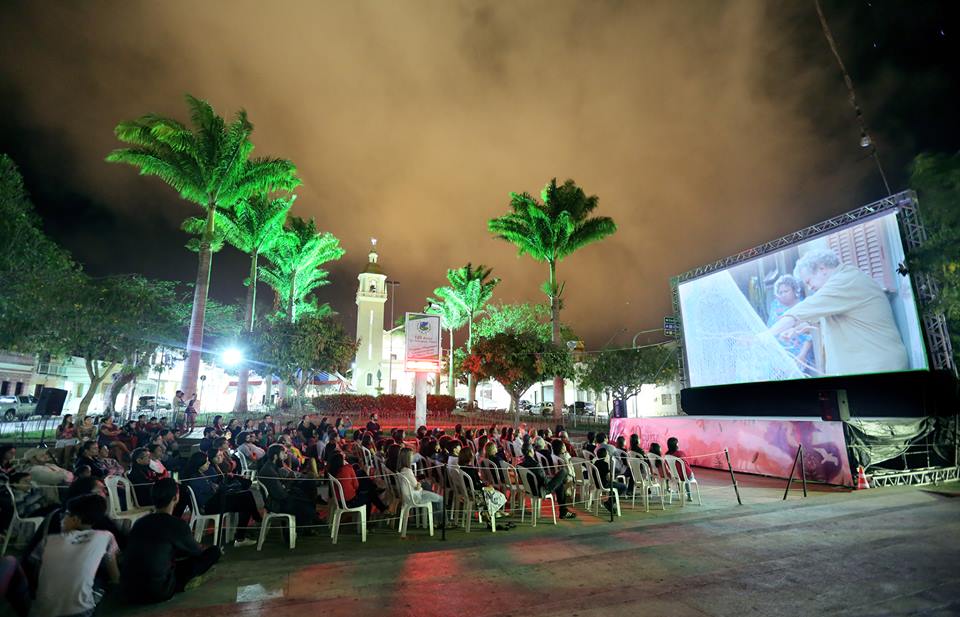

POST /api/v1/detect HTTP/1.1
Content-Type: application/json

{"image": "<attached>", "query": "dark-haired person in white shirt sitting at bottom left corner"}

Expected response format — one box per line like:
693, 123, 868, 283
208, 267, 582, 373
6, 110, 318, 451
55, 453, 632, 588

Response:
31, 495, 120, 617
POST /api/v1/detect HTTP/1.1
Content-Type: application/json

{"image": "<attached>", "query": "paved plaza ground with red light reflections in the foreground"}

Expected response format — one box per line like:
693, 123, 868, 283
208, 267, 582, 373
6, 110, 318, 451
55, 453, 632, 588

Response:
103, 470, 960, 617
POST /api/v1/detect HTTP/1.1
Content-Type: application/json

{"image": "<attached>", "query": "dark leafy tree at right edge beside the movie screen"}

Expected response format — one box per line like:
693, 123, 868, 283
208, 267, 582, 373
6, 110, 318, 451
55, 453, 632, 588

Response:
908, 153, 960, 364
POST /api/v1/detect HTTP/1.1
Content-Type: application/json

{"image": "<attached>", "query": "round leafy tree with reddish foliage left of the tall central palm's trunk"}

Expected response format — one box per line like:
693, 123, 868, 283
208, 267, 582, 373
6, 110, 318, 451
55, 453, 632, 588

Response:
463, 331, 572, 422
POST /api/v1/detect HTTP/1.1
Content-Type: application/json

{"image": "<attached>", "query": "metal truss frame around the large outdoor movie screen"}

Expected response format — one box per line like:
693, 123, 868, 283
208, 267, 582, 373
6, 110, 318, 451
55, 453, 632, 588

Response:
670, 191, 957, 388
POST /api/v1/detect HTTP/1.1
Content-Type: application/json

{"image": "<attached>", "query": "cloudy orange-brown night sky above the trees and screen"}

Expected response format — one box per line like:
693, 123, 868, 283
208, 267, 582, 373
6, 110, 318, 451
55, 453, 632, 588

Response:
0, 0, 960, 348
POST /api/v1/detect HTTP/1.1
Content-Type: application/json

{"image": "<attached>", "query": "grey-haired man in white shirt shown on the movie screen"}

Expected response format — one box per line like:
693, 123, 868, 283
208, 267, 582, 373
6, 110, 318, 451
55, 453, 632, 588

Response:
768, 249, 909, 375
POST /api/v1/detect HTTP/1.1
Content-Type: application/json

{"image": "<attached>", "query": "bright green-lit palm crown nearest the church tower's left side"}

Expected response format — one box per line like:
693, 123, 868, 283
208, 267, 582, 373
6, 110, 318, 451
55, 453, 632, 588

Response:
260, 216, 344, 323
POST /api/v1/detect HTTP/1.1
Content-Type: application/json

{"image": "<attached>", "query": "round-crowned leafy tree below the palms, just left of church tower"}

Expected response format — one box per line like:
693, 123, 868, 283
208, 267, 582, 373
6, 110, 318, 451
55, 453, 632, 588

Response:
256, 315, 357, 401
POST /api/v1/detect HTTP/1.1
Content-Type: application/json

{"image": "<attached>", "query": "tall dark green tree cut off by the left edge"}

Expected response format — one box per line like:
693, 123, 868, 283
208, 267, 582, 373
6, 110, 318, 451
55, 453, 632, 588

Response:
0, 154, 83, 353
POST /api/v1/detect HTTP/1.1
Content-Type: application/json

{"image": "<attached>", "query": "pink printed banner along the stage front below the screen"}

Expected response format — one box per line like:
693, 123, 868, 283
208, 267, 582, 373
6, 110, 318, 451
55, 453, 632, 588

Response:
610, 416, 852, 486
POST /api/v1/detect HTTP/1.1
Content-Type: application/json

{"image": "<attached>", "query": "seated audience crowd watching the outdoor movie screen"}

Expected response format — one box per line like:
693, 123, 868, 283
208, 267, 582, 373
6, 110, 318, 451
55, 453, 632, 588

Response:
0, 414, 684, 617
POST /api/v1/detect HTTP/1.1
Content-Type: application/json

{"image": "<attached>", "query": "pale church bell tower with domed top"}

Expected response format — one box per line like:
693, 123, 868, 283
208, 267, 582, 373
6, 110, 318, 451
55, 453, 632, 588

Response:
353, 238, 389, 395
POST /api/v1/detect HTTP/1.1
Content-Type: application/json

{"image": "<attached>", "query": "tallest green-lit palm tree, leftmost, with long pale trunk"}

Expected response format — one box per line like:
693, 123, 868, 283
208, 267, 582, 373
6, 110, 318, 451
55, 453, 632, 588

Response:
107, 94, 300, 394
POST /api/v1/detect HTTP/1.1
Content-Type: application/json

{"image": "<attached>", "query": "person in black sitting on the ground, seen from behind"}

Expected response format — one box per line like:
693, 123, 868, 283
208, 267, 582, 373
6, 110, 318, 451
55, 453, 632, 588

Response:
120, 478, 220, 604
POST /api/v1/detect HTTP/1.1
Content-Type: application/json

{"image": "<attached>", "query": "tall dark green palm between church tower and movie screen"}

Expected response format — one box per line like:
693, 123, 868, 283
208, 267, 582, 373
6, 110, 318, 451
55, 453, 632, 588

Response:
487, 178, 617, 417
